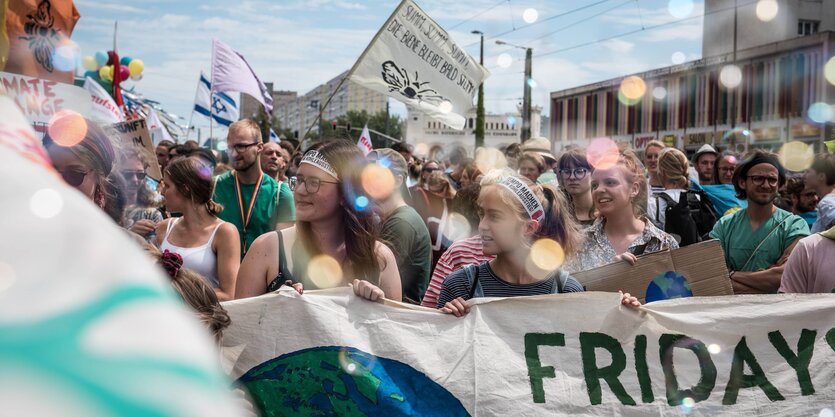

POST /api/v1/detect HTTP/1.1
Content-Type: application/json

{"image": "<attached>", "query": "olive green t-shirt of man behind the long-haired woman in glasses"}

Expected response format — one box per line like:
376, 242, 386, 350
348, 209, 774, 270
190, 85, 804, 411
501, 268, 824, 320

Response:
381, 206, 432, 304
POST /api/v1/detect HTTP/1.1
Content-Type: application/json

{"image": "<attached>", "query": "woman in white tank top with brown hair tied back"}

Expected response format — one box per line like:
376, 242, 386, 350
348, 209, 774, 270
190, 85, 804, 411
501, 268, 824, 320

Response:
154, 157, 241, 301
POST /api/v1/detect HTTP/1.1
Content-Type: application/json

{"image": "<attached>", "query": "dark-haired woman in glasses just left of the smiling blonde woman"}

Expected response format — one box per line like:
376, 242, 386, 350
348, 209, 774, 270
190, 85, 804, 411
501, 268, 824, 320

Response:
557, 149, 597, 228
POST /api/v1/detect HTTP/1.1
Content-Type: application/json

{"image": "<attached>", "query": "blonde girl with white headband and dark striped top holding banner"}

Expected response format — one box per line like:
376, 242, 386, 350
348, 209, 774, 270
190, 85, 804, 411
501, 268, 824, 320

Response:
437, 174, 639, 317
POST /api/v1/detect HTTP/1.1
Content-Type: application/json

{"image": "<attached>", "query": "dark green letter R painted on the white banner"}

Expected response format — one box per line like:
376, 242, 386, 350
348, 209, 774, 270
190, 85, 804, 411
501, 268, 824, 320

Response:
580, 333, 635, 405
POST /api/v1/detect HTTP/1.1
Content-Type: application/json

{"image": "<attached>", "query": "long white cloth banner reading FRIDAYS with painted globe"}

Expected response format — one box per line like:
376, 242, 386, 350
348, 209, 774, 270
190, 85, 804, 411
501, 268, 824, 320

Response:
223, 288, 835, 416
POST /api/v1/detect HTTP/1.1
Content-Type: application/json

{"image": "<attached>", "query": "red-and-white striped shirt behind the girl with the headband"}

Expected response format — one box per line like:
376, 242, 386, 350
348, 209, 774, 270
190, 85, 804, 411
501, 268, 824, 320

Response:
420, 235, 494, 308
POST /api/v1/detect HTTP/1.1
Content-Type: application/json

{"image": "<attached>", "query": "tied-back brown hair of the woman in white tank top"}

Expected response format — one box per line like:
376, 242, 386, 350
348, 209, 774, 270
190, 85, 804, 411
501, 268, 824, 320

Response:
165, 156, 223, 216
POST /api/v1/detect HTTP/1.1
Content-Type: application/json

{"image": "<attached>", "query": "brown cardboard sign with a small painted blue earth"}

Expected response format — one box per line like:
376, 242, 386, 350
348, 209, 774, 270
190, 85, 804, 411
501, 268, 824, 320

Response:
572, 240, 733, 302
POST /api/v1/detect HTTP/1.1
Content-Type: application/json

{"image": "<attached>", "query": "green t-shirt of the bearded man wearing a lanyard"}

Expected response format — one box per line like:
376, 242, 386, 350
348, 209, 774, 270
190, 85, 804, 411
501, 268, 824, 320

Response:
214, 171, 296, 258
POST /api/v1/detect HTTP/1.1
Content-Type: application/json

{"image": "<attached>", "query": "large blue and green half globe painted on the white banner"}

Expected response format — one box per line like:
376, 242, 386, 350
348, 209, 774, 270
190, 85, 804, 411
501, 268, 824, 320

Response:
236, 346, 469, 416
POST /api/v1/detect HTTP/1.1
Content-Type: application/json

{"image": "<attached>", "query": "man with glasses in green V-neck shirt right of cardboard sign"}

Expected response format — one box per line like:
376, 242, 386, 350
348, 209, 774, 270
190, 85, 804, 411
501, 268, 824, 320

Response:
710, 151, 809, 294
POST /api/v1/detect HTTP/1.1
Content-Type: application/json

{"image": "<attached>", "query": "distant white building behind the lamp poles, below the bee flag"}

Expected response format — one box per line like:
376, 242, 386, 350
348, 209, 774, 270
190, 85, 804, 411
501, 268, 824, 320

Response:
405, 106, 542, 156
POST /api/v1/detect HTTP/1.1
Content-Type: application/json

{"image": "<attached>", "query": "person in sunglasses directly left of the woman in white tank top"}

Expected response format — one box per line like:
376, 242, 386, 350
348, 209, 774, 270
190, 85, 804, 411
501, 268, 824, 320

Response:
119, 148, 163, 239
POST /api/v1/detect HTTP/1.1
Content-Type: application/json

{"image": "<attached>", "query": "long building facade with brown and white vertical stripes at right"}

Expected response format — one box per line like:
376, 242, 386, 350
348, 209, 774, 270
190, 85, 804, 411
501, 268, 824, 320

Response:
550, 32, 835, 153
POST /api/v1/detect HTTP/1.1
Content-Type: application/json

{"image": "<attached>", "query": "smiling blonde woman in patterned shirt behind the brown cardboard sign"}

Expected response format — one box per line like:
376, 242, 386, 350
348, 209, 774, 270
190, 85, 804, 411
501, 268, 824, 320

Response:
567, 150, 678, 272
